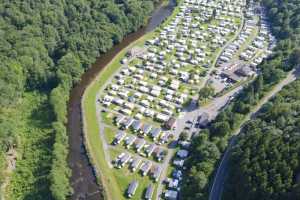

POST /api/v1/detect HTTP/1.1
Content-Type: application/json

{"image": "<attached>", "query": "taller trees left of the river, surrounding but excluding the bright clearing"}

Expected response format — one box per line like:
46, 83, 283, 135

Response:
0, 0, 158, 200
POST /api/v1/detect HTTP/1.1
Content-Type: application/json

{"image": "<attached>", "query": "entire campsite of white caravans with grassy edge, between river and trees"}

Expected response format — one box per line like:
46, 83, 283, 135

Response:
83, 0, 276, 200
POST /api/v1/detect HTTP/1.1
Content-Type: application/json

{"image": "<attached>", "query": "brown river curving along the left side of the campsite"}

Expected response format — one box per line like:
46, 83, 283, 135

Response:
67, 0, 176, 200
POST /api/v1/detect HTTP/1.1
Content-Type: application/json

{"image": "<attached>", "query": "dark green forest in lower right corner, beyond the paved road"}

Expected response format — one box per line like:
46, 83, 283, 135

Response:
223, 80, 300, 200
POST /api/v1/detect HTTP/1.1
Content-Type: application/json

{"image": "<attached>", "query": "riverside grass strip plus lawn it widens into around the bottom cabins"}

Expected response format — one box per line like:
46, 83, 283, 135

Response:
82, 1, 183, 200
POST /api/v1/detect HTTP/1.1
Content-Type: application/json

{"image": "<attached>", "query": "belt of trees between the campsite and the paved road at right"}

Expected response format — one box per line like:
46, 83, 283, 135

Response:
181, 0, 300, 200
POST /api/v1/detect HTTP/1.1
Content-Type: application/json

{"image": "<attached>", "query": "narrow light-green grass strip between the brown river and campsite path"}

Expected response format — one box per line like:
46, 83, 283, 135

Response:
82, 5, 177, 199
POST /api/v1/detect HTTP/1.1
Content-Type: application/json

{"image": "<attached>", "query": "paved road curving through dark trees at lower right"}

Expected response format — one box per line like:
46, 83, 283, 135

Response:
209, 68, 300, 200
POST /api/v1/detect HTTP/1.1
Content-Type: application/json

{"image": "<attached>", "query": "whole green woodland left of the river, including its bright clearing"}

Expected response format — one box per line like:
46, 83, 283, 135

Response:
0, 0, 158, 200
